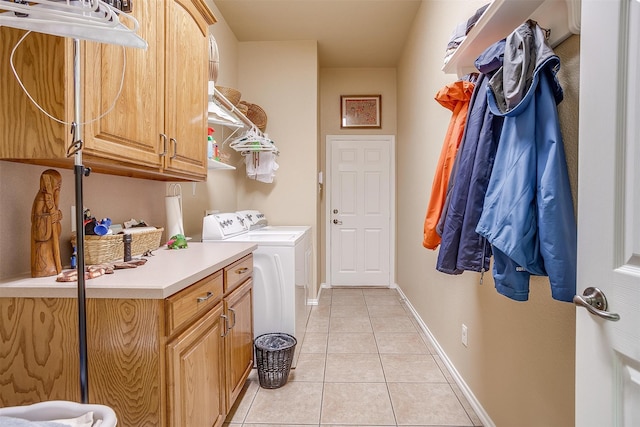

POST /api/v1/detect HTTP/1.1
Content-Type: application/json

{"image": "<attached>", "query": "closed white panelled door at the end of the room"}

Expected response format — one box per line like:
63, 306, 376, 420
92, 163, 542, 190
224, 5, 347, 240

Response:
326, 135, 394, 286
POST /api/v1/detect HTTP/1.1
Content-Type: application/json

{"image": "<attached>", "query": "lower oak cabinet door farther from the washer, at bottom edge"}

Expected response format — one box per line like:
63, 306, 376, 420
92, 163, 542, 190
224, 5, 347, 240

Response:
167, 304, 225, 427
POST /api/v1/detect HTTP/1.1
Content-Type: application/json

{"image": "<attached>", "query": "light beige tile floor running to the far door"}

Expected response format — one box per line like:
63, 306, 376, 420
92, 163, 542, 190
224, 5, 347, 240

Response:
225, 288, 482, 427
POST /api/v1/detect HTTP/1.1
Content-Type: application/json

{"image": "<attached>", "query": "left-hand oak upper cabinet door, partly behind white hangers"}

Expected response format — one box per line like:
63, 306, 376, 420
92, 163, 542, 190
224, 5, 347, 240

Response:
83, 1, 165, 172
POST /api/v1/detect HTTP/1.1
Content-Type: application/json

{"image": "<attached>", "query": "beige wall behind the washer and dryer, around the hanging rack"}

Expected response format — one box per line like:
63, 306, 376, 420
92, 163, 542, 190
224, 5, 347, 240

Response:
189, 19, 318, 295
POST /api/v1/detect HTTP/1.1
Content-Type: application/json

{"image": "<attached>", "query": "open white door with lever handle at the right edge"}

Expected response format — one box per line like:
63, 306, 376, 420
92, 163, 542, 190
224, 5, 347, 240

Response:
576, 0, 640, 427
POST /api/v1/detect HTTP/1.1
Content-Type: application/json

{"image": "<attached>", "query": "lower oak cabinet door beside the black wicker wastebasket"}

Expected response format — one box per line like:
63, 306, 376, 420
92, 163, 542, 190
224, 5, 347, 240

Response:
224, 279, 253, 410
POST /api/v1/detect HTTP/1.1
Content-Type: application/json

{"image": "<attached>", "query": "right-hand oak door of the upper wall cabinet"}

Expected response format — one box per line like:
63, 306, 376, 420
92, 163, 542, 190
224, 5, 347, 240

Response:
164, 0, 215, 179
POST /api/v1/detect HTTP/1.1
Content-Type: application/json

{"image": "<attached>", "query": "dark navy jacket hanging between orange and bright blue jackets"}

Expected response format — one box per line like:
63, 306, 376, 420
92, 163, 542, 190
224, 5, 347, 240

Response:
436, 40, 505, 274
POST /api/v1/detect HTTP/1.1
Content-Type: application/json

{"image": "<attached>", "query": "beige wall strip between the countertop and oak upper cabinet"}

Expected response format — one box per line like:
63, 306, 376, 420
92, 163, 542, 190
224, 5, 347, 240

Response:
0, 161, 166, 279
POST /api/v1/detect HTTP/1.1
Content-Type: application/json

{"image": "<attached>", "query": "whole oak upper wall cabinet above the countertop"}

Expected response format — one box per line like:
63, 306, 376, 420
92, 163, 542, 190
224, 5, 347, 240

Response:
0, 0, 216, 181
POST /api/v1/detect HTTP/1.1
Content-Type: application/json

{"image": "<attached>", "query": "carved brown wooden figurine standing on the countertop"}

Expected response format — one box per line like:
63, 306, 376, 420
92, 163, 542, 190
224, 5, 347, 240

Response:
31, 169, 62, 277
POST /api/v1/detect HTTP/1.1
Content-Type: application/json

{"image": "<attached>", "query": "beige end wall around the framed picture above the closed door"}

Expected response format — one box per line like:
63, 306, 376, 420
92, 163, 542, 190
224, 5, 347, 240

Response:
318, 68, 397, 283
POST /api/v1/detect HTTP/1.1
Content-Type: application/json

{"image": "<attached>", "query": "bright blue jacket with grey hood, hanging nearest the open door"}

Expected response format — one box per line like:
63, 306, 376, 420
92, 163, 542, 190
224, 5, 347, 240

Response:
476, 21, 576, 302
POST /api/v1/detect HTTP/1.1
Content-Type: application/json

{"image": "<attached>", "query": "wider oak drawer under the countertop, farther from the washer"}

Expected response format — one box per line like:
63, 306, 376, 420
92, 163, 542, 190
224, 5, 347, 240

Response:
165, 270, 223, 335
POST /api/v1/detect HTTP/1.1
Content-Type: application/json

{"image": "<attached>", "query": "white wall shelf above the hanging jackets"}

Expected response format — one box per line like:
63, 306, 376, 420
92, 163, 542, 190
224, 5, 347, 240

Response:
442, 0, 580, 77
